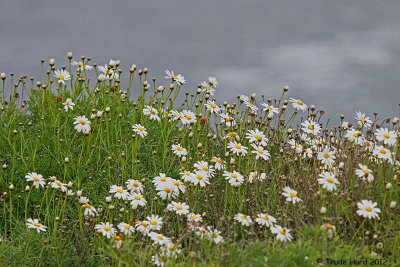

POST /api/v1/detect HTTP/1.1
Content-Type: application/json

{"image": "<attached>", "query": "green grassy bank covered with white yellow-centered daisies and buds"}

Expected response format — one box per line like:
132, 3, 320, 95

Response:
0, 54, 400, 266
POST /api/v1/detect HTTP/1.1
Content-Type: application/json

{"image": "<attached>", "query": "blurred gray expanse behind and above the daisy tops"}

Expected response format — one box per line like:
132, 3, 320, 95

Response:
0, 0, 400, 119
